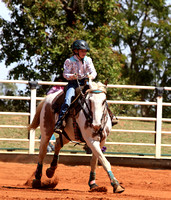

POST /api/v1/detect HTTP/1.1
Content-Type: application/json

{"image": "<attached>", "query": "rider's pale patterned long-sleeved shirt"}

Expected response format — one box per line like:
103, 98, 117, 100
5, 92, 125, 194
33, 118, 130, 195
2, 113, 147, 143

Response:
63, 55, 97, 80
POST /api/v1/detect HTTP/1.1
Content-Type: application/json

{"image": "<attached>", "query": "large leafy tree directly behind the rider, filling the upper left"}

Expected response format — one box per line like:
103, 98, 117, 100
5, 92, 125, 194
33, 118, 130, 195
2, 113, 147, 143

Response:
0, 0, 123, 81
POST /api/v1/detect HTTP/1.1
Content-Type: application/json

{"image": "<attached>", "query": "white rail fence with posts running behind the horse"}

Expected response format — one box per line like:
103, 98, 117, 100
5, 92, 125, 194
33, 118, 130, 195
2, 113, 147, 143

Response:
0, 80, 171, 158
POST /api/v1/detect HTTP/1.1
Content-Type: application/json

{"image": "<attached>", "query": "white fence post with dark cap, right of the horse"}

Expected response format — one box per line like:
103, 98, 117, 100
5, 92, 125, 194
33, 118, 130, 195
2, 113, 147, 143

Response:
155, 87, 164, 158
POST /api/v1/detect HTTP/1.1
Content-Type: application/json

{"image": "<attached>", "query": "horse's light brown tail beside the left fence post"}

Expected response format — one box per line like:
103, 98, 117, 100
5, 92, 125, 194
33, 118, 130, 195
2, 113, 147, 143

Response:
28, 99, 45, 130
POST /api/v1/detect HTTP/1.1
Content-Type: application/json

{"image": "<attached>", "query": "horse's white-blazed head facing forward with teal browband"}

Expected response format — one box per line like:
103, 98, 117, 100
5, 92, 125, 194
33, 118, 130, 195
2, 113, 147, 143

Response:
86, 82, 107, 131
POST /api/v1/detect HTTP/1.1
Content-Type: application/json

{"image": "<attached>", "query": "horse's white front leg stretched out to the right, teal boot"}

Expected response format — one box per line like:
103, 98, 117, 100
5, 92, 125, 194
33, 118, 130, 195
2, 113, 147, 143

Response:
87, 139, 125, 193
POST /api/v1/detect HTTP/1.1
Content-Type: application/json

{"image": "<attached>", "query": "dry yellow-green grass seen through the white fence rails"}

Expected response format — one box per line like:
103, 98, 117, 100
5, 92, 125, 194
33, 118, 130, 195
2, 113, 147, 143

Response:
0, 115, 171, 156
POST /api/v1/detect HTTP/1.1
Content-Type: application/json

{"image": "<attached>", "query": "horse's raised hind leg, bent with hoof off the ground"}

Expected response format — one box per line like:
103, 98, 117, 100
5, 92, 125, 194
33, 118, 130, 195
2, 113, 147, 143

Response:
46, 135, 69, 178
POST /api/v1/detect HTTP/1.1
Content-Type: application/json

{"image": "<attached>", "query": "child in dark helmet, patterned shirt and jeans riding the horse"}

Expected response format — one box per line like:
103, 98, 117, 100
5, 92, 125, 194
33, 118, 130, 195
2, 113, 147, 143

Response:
54, 40, 97, 132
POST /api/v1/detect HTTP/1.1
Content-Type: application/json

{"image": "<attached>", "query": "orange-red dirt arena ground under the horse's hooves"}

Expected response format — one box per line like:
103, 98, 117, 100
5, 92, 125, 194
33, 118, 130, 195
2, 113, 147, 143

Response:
0, 162, 171, 200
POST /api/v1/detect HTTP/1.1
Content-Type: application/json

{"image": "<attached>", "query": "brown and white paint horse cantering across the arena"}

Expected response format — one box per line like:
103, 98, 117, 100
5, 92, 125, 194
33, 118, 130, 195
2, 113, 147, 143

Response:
28, 80, 124, 193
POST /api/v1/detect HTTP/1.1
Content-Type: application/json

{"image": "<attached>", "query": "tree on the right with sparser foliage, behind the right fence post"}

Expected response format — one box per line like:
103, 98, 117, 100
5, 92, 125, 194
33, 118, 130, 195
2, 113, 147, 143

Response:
113, 0, 171, 116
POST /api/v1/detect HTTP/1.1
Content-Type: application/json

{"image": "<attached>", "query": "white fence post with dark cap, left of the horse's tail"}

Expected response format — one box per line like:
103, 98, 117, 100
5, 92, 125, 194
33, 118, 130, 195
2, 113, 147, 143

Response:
29, 81, 38, 154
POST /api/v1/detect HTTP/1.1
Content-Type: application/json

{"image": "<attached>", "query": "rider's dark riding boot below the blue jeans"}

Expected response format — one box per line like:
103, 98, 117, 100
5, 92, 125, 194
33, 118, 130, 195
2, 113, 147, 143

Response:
54, 104, 69, 133
